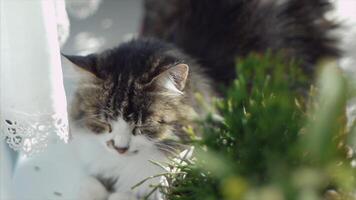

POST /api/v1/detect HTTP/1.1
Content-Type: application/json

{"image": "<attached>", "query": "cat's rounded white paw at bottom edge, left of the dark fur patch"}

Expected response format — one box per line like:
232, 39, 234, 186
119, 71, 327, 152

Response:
78, 176, 109, 200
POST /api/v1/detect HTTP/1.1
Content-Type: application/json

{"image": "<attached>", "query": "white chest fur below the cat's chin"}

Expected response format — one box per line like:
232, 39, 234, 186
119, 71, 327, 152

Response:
73, 125, 167, 200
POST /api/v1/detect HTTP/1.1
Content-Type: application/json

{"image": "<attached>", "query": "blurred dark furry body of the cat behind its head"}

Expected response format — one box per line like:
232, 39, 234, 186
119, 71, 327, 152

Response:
140, 0, 341, 86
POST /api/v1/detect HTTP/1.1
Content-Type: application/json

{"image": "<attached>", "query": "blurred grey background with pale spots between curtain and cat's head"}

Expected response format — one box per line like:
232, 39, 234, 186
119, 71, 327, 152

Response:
61, 0, 143, 102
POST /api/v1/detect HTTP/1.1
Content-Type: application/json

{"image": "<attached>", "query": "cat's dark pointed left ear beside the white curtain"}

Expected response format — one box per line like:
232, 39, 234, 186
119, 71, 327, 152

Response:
62, 53, 100, 78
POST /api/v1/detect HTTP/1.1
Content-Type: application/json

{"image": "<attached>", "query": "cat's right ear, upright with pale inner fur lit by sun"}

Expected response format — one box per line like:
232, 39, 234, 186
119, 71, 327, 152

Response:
153, 64, 189, 94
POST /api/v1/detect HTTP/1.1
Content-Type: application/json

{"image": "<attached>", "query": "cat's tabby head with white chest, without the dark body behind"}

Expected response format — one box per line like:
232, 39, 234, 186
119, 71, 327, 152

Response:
65, 39, 215, 200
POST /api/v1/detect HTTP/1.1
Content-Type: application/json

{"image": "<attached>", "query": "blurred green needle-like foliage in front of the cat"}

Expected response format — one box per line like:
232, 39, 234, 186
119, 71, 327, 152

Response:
145, 53, 356, 200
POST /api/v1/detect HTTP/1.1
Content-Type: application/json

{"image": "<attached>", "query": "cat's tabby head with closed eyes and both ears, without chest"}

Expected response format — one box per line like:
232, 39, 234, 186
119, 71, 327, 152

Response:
65, 40, 194, 154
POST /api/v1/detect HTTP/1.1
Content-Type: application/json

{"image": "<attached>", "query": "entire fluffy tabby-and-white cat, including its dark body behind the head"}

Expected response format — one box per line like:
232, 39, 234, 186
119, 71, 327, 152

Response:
66, 0, 339, 200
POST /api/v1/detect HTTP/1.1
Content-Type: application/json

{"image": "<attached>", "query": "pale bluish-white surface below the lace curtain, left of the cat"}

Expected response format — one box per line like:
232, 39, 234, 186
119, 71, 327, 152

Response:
12, 139, 84, 200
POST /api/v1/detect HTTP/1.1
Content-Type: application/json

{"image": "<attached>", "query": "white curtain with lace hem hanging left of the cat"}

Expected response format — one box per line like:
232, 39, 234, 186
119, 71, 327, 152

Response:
0, 0, 69, 154
